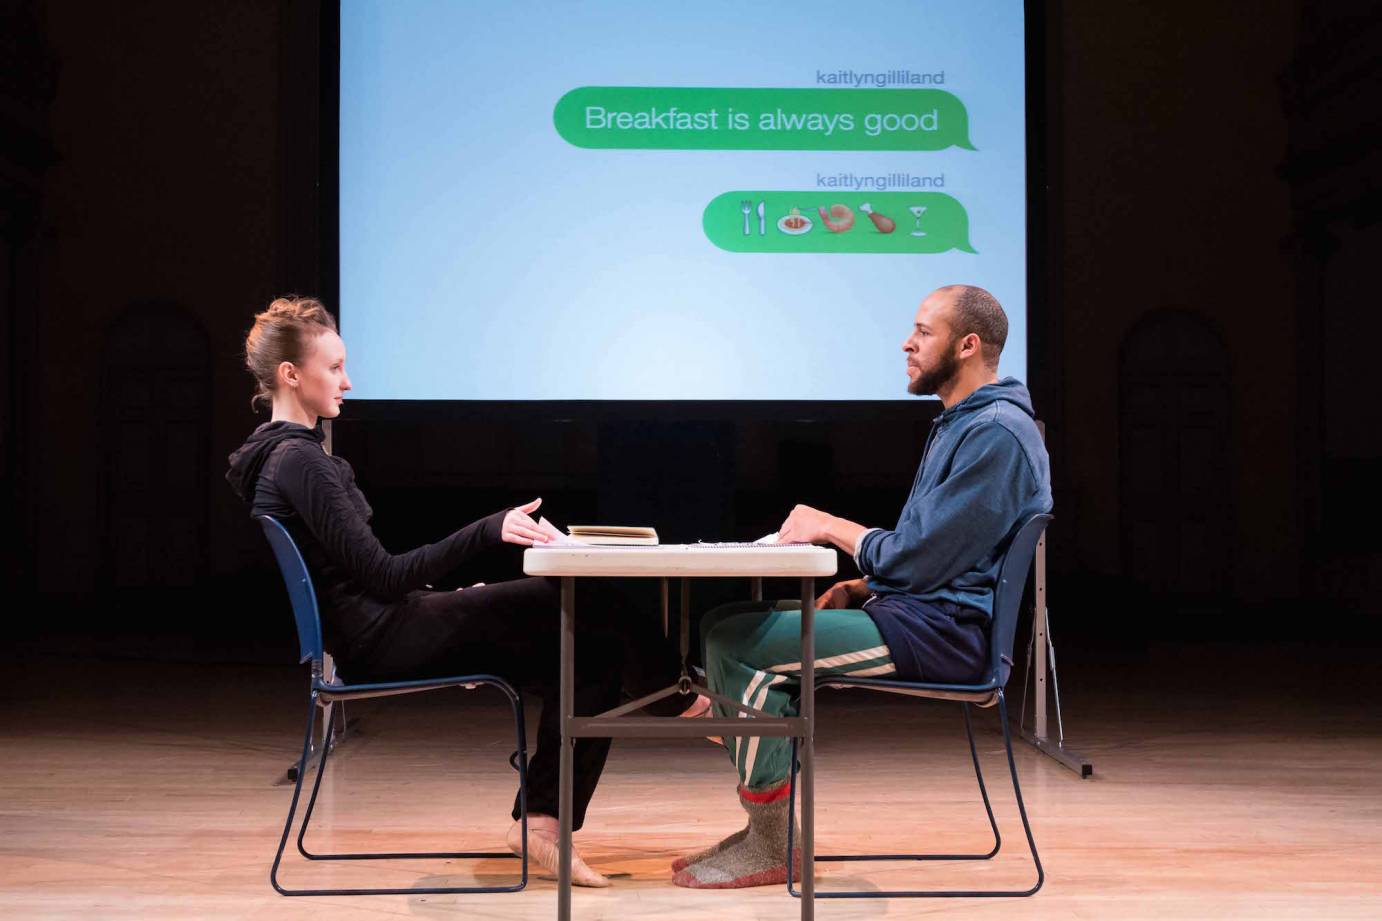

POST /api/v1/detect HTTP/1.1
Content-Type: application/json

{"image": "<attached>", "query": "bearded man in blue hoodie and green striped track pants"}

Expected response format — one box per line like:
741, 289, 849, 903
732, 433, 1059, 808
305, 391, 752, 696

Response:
673, 285, 1050, 889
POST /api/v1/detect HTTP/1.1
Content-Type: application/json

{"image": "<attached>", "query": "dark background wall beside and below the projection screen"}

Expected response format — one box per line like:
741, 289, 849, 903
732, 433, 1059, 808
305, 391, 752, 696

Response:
0, 0, 1382, 657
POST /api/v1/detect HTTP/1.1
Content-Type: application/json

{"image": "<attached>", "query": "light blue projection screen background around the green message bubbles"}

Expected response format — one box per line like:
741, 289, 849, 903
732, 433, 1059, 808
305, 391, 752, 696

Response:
339, 0, 1027, 400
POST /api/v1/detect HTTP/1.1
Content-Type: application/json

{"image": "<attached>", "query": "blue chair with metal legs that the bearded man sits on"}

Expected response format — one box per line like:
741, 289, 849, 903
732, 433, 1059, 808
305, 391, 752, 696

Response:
786, 514, 1052, 899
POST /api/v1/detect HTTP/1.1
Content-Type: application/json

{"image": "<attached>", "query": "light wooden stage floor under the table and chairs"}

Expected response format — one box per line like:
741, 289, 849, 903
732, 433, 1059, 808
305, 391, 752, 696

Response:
0, 650, 1382, 921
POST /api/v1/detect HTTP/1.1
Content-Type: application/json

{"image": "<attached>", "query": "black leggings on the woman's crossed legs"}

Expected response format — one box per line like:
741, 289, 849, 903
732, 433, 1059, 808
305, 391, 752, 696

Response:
341, 578, 677, 828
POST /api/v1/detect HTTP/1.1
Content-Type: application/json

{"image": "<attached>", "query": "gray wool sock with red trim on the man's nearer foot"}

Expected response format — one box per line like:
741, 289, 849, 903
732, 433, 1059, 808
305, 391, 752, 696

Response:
672, 783, 802, 889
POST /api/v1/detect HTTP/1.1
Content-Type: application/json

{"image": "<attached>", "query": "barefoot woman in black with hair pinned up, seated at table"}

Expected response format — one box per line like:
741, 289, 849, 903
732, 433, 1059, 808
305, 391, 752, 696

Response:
227, 297, 676, 886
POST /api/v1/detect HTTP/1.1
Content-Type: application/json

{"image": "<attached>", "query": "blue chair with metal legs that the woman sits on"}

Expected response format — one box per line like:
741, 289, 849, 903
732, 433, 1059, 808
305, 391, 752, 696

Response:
260, 514, 528, 896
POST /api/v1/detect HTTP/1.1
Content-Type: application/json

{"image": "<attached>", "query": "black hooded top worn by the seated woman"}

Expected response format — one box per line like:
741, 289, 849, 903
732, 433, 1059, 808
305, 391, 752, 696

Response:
225, 422, 507, 661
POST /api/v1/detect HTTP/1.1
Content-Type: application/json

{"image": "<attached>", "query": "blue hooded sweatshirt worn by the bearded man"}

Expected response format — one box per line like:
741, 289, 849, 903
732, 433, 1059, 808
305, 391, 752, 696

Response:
854, 378, 1052, 680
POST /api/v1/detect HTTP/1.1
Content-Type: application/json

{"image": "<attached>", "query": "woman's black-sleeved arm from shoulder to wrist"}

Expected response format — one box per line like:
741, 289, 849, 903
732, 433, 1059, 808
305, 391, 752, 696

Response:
274, 443, 509, 597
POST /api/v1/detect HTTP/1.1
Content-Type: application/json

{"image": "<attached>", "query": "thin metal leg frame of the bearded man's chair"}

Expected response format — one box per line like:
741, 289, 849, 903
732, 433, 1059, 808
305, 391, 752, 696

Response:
786, 691, 1045, 899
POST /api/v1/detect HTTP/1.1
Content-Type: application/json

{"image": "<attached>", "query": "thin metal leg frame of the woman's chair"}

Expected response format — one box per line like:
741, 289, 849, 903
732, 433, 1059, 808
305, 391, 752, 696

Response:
269, 680, 528, 896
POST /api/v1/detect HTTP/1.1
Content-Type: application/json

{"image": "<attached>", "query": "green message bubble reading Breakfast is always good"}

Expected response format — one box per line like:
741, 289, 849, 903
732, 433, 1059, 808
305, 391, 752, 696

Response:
551, 86, 974, 151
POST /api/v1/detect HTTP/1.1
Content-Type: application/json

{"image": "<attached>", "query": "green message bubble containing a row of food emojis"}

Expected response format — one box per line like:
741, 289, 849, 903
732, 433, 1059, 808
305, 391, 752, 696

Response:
701, 189, 974, 254
